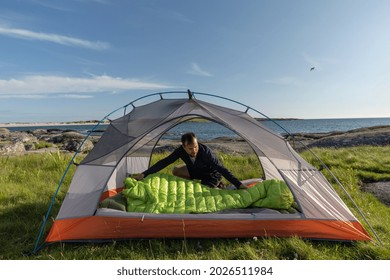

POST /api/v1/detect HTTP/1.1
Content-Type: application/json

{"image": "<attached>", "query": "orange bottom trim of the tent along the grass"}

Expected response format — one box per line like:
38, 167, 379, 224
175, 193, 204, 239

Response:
46, 216, 371, 243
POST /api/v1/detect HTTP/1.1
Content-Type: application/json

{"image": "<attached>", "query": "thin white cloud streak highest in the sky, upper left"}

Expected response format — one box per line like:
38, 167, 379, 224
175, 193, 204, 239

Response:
0, 26, 110, 50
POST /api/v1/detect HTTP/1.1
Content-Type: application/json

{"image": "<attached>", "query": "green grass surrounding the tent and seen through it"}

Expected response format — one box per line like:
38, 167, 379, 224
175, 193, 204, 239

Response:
0, 147, 390, 260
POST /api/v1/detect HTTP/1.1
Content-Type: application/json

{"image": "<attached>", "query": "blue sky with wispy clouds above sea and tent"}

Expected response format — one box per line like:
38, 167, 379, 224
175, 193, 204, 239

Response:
0, 0, 390, 123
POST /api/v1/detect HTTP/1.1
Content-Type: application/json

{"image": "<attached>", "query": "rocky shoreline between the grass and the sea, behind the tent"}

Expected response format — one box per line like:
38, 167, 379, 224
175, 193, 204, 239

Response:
0, 126, 390, 156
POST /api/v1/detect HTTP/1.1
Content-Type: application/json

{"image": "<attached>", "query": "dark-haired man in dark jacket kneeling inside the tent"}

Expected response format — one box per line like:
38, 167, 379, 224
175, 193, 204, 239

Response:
133, 132, 246, 189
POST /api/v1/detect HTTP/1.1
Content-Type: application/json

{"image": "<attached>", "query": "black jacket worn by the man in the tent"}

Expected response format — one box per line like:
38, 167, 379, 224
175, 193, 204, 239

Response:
143, 143, 241, 188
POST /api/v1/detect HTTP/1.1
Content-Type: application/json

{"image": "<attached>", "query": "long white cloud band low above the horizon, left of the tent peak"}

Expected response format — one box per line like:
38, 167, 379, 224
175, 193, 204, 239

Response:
0, 75, 174, 98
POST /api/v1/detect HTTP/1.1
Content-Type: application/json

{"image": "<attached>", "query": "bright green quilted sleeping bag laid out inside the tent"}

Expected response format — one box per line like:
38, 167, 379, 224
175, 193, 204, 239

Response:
123, 173, 293, 214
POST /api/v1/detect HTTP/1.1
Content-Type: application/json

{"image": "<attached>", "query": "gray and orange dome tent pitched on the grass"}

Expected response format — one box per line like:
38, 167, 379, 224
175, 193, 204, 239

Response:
35, 91, 371, 253
